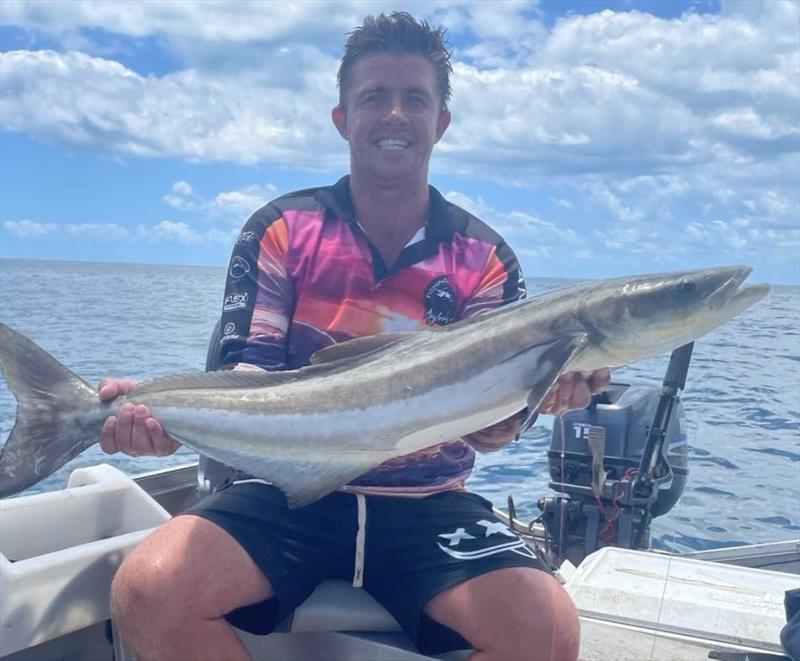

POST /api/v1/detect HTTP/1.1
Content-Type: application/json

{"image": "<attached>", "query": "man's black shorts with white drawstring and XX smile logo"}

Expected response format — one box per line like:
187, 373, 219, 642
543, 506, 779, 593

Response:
187, 481, 546, 654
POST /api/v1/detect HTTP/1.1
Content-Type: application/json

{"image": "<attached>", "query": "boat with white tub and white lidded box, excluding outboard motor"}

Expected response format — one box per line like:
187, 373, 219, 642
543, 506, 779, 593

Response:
0, 464, 800, 661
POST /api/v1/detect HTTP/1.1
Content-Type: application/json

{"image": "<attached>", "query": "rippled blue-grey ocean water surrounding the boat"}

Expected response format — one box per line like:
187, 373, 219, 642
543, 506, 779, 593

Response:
0, 260, 800, 552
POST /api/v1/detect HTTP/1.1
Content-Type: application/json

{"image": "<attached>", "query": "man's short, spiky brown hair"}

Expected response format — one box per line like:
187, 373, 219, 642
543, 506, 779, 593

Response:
336, 11, 453, 108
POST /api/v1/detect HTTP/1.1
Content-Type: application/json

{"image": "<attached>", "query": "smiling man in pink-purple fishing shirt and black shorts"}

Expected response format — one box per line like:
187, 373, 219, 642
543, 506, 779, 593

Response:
100, 13, 608, 661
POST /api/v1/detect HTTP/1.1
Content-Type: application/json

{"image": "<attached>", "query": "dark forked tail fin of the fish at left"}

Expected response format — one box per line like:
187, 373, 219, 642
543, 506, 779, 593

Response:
0, 324, 102, 497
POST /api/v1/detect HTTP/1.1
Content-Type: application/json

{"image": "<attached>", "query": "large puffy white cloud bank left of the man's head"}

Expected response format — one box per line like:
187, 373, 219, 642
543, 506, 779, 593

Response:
0, 51, 346, 169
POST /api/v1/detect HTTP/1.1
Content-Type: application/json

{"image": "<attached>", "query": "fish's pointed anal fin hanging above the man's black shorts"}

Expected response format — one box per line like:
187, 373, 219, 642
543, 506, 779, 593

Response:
188, 448, 393, 509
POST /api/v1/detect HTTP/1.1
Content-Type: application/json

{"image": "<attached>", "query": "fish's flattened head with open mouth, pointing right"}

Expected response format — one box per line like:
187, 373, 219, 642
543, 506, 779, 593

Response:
581, 266, 769, 365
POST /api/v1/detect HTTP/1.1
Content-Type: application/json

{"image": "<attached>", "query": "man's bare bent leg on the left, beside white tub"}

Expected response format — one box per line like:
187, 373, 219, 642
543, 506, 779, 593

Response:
111, 515, 274, 661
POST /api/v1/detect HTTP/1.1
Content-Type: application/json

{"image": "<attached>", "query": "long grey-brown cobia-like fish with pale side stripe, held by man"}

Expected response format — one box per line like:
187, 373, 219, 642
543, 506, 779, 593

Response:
0, 266, 769, 508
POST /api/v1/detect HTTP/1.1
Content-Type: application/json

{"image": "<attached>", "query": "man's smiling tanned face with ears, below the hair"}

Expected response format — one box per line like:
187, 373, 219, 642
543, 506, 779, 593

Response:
332, 53, 450, 183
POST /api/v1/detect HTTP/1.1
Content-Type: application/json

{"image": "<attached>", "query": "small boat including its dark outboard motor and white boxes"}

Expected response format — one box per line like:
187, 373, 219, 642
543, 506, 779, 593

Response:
0, 342, 800, 661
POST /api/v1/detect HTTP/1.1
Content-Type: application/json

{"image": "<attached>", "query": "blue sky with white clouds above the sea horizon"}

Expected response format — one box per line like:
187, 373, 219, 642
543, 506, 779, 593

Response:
0, 0, 800, 285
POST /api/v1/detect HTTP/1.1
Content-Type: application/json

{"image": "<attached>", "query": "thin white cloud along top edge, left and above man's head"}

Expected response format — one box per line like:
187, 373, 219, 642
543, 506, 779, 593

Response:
3, 0, 520, 73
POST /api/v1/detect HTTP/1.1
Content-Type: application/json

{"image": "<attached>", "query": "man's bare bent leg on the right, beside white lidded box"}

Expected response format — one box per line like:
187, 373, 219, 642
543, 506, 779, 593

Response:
425, 567, 580, 661
